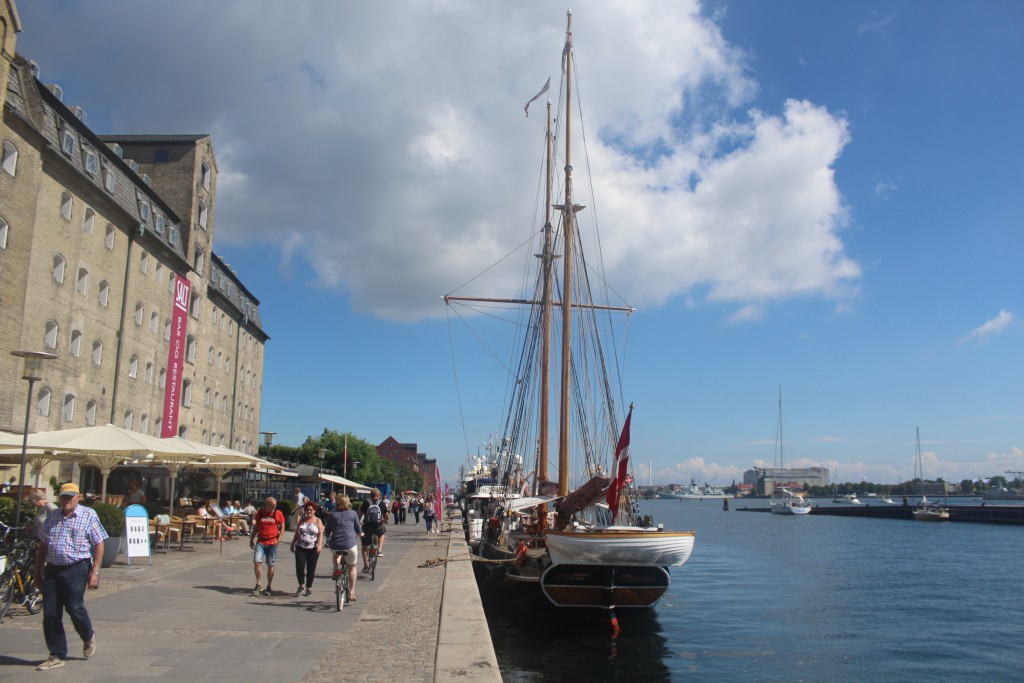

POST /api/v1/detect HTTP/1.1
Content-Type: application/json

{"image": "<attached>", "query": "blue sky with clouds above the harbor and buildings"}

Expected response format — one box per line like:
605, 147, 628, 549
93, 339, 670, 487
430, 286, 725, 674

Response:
17, 0, 1024, 485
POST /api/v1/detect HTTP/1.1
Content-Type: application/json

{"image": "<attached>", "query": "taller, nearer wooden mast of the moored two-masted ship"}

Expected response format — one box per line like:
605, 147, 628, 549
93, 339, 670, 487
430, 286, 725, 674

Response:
558, 10, 575, 496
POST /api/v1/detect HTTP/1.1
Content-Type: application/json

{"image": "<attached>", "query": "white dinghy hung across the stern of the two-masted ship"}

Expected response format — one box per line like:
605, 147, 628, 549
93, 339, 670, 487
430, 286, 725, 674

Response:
545, 527, 693, 566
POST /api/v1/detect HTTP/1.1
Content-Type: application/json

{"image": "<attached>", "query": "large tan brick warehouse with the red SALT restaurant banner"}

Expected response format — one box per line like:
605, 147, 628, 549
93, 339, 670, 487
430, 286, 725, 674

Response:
0, 0, 268, 485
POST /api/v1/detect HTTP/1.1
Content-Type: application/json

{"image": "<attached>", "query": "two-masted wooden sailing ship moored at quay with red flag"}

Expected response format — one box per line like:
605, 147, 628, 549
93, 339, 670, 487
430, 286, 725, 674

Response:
444, 11, 694, 616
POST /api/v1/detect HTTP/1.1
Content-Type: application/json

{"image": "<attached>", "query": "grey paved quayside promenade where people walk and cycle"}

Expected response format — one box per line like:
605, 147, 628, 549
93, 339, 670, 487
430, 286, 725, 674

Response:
0, 511, 500, 683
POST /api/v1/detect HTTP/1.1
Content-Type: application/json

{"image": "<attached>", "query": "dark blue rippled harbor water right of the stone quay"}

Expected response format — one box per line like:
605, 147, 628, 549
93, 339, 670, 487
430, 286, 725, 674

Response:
481, 500, 1024, 683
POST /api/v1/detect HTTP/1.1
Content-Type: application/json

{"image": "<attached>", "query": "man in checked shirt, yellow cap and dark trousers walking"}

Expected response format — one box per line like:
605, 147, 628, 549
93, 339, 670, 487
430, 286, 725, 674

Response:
36, 483, 106, 671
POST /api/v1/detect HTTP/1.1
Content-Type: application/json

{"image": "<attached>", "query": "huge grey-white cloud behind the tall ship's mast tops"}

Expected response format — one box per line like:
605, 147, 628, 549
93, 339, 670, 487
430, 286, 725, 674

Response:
18, 0, 860, 319
